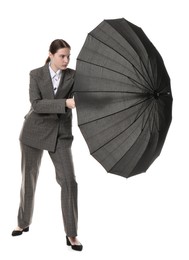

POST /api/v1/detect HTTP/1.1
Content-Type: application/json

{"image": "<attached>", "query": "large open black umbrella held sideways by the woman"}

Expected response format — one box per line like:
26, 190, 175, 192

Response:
74, 19, 172, 177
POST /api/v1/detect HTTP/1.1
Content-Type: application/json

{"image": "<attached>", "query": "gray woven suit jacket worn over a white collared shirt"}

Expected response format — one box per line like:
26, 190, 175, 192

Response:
20, 64, 75, 151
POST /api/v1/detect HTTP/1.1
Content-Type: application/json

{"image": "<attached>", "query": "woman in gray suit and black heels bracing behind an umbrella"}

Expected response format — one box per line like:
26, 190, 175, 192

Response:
12, 39, 82, 251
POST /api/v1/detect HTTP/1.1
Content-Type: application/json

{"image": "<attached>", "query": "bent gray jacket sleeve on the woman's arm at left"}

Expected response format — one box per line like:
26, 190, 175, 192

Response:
29, 73, 67, 114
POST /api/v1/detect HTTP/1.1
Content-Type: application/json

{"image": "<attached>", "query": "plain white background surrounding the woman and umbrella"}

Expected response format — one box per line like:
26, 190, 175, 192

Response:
0, 0, 189, 260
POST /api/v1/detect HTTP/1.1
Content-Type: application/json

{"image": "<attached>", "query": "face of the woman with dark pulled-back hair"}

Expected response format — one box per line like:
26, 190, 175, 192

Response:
49, 48, 70, 72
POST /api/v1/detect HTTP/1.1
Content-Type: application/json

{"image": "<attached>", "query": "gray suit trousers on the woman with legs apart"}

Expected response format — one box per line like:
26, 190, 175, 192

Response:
18, 143, 78, 237
